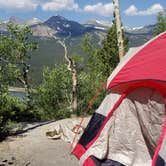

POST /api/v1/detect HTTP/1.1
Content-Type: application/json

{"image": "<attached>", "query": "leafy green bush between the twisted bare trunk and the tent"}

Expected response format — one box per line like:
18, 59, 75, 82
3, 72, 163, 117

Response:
78, 34, 105, 114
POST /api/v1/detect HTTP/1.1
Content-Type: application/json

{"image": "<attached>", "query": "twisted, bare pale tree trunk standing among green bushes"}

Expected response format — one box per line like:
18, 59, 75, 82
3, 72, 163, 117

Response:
58, 40, 78, 113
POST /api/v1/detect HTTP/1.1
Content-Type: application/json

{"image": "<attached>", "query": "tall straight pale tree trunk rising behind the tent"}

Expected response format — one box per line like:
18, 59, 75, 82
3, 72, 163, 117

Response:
113, 0, 125, 60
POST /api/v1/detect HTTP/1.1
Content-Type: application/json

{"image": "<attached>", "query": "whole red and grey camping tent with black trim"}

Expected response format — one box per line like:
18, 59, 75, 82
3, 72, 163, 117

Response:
72, 32, 166, 166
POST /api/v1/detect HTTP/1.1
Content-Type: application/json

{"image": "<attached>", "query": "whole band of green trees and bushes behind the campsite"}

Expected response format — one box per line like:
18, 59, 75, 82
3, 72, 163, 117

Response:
0, 13, 166, 137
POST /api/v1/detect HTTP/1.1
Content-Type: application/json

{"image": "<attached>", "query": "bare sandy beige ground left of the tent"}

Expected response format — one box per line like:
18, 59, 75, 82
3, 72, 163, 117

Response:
0, 121, 78, 166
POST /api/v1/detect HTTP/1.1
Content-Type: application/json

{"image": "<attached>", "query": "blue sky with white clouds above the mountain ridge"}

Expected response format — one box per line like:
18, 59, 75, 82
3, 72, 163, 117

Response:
0, 0, 166, 27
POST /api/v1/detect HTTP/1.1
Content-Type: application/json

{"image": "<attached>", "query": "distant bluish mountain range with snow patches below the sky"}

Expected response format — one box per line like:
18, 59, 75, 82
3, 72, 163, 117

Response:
0, 15, 155, 41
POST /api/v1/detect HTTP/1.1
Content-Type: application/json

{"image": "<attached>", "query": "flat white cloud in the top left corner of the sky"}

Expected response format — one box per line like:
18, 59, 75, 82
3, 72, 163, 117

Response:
0, 0, 37, 11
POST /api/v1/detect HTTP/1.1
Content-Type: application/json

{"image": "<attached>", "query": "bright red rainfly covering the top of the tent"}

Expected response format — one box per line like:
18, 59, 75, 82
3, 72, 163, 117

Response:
107, 32, 166, 94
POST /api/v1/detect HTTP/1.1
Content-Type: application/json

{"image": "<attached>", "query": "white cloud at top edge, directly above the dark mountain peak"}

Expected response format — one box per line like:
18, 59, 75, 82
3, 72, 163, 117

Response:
42, 0, 79, 11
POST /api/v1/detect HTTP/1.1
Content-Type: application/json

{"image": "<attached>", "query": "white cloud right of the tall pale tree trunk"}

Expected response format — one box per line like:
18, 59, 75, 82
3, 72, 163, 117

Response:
124, 3, 164, 16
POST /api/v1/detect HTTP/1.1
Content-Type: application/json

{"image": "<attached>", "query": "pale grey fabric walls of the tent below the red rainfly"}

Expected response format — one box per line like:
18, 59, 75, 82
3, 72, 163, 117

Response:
80, 87, 165, 166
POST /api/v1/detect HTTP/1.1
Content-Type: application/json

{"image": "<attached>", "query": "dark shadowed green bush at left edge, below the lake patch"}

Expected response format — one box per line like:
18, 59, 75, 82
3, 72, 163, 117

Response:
0, 93, 40, 133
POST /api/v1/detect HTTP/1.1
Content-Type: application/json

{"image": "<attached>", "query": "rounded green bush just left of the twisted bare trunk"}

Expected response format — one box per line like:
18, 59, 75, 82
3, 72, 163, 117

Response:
34, 65, 71, 119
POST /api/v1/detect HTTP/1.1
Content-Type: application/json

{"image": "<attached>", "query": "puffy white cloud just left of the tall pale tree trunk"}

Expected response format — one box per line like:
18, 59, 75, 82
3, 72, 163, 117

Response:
83, 3, 114, 16
